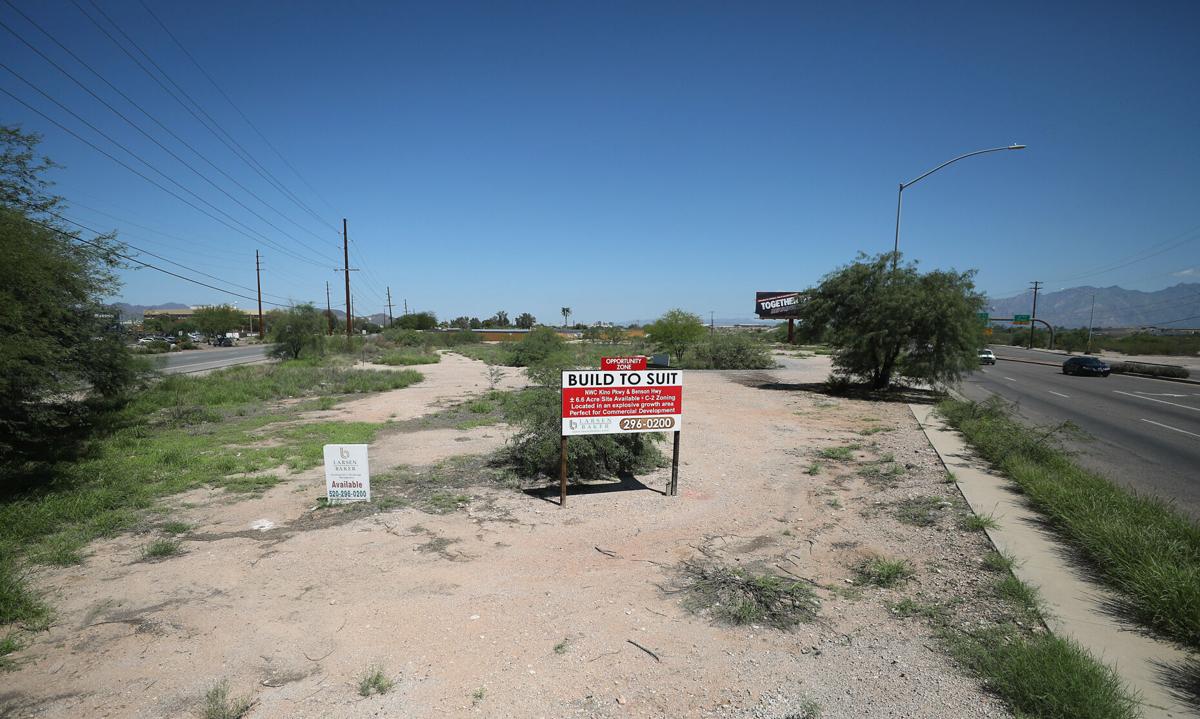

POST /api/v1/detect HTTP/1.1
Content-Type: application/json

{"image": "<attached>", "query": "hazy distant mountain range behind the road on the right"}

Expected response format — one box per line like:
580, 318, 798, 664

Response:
988, 282, 1200, 328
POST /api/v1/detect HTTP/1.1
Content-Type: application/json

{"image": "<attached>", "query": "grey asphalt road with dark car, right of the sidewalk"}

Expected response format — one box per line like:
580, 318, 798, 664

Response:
962, 347, 1200, 519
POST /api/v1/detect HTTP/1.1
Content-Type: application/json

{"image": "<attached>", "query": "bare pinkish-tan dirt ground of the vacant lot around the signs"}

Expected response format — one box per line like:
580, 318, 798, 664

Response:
0, 355, 1008, 719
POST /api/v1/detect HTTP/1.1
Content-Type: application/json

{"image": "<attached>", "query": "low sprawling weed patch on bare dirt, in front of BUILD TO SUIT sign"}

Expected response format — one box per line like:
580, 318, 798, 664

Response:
679, 562, 820, 630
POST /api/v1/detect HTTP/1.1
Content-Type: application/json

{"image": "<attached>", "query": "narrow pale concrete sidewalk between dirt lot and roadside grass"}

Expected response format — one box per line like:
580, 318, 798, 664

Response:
908, 405, 1200, 719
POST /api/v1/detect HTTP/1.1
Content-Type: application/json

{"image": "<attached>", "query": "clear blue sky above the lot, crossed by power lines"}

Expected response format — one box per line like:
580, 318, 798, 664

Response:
0, 0, 1200, 322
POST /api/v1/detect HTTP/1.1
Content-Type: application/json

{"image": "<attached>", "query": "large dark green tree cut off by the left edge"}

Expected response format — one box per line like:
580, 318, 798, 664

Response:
0, 127, 139, 468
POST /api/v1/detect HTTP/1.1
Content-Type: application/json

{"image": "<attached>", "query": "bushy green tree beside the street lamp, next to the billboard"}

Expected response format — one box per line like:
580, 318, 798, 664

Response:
802, 253, 984, 389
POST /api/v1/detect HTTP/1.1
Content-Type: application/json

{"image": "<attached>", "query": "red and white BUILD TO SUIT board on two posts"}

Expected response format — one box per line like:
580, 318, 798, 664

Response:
563, 370, 683, 437
